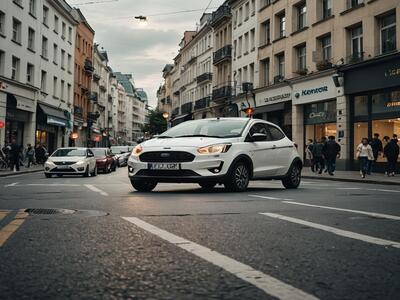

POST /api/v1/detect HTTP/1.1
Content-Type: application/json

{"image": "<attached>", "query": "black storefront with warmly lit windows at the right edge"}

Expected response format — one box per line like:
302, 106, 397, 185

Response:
341, 53, 400, 171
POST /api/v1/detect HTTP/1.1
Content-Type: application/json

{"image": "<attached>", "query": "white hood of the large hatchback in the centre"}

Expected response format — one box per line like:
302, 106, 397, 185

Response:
141, 137, 233, 149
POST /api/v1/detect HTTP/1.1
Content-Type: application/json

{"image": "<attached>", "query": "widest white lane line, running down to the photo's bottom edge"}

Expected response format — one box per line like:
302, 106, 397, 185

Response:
123, 217, 318, 300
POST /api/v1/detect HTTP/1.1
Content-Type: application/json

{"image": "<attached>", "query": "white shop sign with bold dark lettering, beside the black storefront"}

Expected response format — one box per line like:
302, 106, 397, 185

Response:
293, 75, 343, 105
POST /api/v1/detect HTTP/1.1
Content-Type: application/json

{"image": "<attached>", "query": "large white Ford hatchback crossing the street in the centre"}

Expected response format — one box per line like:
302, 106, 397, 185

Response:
128, 118, 303, 192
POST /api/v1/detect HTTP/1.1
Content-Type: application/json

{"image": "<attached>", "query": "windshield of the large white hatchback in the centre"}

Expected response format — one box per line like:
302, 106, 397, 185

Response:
158, 118, 249, 139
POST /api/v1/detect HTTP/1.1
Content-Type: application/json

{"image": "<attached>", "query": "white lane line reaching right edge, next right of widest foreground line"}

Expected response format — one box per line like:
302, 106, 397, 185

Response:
260, 213, 400, 249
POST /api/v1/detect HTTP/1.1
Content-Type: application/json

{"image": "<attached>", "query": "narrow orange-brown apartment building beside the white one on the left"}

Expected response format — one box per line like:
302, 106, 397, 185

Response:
70, 9, 94, 146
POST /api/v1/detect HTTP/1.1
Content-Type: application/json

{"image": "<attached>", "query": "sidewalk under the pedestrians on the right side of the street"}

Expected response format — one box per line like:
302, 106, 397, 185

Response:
302, 167, 400, 186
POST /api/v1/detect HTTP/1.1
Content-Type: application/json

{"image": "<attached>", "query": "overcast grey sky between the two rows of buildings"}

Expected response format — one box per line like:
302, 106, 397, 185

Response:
68, 0, 223, 106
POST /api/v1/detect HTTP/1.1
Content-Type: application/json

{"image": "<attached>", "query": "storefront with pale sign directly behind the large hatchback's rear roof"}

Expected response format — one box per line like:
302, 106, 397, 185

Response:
255, 85, 292, 139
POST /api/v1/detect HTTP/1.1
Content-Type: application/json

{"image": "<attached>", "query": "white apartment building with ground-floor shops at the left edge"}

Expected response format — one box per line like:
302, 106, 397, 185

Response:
0, 0, 77, 152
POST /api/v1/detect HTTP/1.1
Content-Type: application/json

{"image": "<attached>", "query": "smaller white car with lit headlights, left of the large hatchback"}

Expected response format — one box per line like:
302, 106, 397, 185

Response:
44, 147, 97, 178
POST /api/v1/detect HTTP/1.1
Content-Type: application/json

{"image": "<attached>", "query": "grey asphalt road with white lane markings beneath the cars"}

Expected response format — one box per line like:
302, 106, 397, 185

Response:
0, 168, 400, 299
